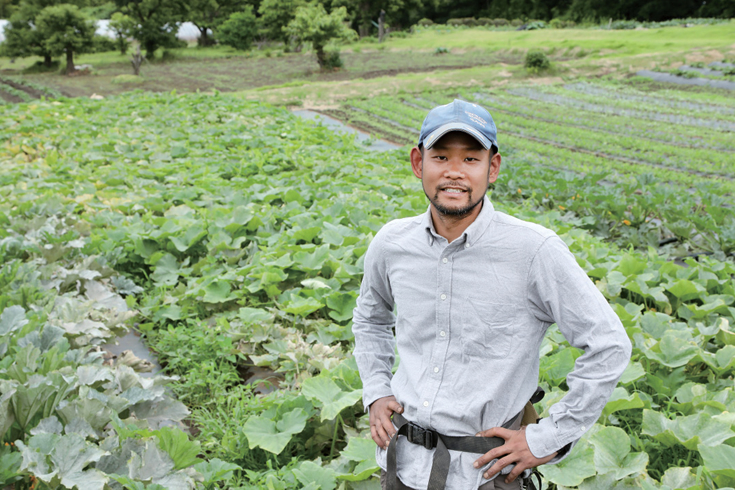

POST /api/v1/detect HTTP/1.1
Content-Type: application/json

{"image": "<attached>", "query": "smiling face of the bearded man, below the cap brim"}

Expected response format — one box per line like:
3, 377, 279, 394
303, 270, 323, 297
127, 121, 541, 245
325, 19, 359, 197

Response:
411, 131, 500, 217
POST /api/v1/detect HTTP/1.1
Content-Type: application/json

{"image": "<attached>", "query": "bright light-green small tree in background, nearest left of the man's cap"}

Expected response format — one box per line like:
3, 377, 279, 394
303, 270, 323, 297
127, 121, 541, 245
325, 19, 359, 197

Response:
284, 3, 357, 70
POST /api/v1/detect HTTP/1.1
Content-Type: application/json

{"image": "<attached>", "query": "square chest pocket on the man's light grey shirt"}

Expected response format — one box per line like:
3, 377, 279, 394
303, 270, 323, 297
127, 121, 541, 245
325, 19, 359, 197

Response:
460, 298, 519, 360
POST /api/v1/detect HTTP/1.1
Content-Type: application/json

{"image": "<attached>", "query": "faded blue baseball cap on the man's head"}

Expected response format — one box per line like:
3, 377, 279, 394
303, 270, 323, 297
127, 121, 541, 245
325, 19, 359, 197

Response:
418, 99, 498, 150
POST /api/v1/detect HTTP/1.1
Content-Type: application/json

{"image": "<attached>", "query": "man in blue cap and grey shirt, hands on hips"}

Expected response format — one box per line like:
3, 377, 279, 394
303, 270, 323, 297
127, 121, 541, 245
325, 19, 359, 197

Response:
353, 100, 631, 490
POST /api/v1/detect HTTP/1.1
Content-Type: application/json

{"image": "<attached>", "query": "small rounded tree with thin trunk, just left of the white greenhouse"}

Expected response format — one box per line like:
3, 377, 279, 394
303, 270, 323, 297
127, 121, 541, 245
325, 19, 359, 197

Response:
36, 3, 94, 75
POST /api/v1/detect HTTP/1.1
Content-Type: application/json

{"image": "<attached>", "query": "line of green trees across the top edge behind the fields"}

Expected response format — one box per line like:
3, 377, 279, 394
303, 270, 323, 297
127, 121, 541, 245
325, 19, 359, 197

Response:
0, 0, 735, 71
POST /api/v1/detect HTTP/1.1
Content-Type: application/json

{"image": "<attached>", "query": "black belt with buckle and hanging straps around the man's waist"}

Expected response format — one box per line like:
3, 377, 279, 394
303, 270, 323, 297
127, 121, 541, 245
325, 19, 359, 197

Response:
386, 410, 541, 490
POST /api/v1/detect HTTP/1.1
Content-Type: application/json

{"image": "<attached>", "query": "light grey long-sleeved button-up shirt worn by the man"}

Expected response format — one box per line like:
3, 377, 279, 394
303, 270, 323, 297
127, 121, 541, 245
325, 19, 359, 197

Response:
353, 197, 631, 490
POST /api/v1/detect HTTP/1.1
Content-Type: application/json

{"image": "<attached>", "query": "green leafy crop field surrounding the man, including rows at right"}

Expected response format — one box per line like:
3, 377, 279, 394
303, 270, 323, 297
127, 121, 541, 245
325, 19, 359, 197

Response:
0, 82, 735, 490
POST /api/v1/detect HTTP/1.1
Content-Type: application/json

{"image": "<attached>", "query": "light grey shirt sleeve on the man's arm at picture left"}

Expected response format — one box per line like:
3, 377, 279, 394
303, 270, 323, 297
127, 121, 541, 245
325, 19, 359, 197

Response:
352, 230, 395, 411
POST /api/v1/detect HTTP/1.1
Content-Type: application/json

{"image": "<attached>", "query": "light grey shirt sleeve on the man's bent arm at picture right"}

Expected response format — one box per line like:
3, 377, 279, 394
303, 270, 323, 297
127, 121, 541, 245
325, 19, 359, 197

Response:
526, 236, 632, 464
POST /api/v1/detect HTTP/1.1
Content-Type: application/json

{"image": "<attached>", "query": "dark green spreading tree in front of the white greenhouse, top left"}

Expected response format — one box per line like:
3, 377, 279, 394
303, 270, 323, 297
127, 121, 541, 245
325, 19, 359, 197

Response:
115, 0, 188, 60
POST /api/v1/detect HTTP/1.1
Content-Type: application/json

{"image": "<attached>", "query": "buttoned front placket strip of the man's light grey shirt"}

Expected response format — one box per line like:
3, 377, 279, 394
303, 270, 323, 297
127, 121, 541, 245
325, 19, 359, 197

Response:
418, 241, 458, 427
